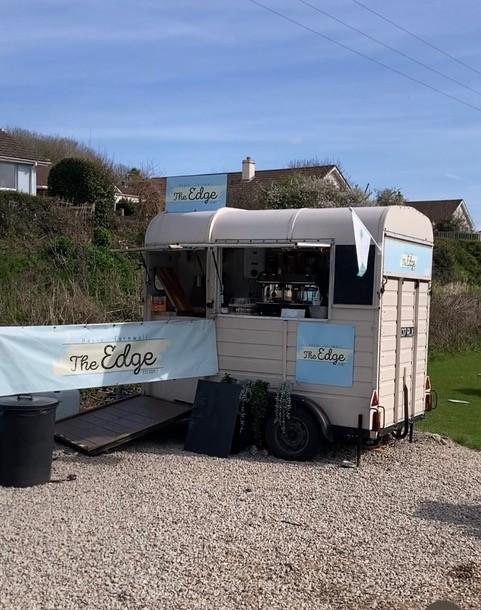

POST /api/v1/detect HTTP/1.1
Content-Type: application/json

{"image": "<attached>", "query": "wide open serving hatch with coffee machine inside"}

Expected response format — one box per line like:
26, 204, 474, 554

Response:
220, 246, 330, 318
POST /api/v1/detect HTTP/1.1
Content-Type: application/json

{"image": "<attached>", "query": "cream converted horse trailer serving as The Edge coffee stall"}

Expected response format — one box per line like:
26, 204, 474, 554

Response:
141, 206, 433, 460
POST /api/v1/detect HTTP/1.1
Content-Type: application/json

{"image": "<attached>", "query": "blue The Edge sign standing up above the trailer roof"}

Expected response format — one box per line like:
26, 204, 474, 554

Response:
165, 174, 227, 212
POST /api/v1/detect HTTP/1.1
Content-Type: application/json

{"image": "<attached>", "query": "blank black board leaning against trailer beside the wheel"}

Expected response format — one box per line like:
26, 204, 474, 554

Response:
184, 380, 242, 457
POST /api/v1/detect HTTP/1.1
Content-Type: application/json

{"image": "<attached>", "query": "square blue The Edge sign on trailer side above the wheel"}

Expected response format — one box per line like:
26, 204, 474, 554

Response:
296, 322, 355, 387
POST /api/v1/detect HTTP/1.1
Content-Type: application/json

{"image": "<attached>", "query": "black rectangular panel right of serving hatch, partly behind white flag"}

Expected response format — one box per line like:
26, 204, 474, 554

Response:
334, 246, 375, 305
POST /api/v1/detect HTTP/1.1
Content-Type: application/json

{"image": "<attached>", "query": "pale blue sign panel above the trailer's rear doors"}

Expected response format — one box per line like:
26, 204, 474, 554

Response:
384, 237, 433, 278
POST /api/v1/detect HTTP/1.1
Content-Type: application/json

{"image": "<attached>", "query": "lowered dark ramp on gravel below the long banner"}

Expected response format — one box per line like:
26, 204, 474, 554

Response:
55, 396, 192, 455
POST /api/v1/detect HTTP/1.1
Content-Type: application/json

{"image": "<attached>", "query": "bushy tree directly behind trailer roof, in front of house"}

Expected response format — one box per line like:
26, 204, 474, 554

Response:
259, 174, 373, 209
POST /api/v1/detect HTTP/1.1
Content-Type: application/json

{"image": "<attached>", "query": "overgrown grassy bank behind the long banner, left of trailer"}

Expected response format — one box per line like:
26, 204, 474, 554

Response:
0, 193, 143, 325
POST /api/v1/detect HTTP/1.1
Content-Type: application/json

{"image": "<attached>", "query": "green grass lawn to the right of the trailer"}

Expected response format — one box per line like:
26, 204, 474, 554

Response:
416, 352, 481, 449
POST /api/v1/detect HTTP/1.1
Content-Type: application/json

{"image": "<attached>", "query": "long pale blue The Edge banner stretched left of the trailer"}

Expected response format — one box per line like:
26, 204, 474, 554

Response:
0, 319, 218, 396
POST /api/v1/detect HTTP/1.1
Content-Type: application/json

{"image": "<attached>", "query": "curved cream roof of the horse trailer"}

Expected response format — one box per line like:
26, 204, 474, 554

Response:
145, 206, 433, 249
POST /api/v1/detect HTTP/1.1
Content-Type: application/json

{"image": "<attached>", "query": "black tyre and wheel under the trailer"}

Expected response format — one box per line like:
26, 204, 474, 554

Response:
266, 405, 323, 462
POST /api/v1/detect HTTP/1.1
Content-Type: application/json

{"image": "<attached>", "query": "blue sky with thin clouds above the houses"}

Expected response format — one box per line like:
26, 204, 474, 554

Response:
0, 0, 481, 224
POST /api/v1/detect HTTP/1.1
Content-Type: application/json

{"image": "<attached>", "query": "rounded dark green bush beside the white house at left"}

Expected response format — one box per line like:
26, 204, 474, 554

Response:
48, 157, 114, 208
